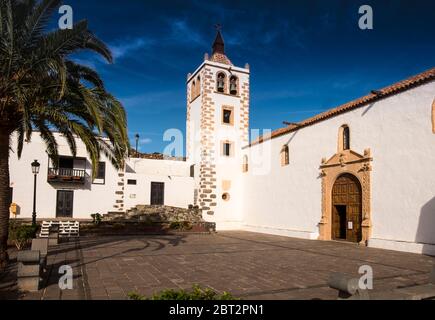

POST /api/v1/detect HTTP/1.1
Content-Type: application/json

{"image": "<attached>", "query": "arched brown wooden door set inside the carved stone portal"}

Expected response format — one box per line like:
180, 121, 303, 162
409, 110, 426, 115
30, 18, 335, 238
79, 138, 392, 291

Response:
332, 174, 362, 242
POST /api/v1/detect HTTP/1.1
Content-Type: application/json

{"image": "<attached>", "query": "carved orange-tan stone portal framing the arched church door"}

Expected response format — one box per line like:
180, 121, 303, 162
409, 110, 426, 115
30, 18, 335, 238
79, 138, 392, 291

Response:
319, 149, 373, 245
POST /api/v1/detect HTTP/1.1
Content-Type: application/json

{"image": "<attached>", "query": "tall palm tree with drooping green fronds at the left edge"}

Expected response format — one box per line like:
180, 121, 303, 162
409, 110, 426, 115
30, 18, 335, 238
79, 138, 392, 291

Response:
0, 0, 130, 267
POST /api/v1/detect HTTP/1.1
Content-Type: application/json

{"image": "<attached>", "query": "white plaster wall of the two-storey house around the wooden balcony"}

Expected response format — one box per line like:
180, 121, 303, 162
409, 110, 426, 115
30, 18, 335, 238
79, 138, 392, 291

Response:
9, 132, 118, 219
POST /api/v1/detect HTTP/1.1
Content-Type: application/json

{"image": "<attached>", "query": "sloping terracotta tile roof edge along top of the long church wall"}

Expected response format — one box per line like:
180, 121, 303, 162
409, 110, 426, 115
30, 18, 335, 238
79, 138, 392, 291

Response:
247, 68, 435, 147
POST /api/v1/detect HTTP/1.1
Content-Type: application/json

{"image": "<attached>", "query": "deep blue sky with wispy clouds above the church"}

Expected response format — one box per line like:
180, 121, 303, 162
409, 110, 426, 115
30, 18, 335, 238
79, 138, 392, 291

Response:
65, 0, 435, 152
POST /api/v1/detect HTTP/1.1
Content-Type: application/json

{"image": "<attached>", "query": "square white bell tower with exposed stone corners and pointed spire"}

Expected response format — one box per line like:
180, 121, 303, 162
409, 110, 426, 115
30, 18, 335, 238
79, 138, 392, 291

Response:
186, 28, 250, 230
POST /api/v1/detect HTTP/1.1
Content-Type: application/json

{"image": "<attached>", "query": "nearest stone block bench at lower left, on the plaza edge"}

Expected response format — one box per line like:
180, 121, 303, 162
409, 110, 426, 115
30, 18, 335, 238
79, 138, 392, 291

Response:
17, 250, 41, 292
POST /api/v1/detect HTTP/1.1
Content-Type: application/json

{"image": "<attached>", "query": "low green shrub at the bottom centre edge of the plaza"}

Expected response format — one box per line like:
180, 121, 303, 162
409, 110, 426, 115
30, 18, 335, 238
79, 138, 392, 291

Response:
128, 285, 237, 301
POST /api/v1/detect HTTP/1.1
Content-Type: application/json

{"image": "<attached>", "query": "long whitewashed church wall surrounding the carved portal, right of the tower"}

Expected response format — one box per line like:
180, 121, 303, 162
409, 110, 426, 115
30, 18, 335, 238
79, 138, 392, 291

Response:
243, 82, 435, 251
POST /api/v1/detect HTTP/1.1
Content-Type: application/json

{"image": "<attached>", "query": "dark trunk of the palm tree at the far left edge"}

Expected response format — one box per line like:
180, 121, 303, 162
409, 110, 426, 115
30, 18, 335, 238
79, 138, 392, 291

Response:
0, 129, 10, 270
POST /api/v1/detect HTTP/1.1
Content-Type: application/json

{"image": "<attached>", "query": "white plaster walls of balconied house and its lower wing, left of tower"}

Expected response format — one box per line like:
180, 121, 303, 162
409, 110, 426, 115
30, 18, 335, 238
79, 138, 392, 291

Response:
9, 133, 194, 219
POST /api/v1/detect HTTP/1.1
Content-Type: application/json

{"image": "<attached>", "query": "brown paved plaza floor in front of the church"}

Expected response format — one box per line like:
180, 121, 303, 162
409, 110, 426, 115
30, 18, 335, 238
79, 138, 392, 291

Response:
1, 232, 435, 300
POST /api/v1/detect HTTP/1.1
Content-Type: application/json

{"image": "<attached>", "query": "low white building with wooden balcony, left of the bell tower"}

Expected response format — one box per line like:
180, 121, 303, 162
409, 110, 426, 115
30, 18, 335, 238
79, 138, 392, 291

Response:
10, 133, 194, 219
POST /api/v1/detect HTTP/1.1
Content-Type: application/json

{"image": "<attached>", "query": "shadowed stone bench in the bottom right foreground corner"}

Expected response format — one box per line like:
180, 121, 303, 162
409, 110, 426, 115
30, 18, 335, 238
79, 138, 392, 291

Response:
328, 267, 435, 300
